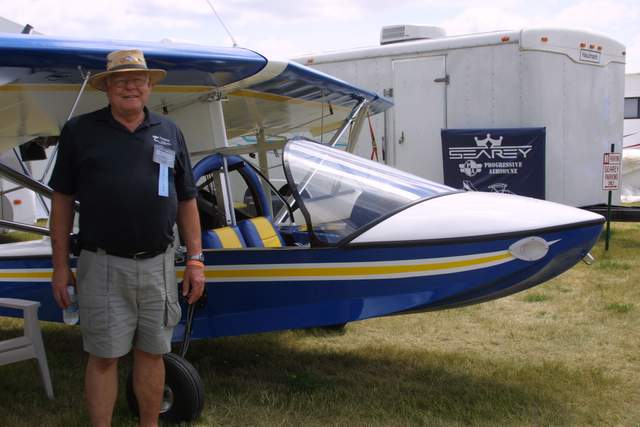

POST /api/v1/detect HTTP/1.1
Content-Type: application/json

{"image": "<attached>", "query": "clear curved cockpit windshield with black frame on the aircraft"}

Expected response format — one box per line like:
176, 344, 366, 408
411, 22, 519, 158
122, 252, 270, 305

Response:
283, 140, 458, 244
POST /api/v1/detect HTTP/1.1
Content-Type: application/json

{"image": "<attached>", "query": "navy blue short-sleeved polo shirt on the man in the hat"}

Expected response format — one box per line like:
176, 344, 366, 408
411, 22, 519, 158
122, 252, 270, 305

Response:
49, 107, 197, 253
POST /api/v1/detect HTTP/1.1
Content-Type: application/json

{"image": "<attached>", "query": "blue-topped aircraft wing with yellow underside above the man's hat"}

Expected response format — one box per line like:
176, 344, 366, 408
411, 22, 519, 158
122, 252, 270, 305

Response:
0, 34, 392, 152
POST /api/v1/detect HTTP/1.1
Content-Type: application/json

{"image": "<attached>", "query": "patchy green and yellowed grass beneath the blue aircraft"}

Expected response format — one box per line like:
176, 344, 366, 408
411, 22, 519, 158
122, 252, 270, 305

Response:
0, 223, 640, 427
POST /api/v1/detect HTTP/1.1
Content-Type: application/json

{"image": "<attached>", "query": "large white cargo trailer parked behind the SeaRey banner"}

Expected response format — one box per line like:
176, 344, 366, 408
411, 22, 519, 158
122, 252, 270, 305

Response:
296, 26, 625, 206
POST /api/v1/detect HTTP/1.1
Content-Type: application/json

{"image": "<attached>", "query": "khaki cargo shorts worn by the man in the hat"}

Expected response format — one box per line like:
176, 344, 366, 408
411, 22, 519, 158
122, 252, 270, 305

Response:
77, 247, 181, 358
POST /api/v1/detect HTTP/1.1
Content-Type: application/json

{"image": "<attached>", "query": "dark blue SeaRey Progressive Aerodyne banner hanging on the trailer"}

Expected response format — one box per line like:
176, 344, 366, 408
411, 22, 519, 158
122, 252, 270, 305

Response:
441, 128, 546, 199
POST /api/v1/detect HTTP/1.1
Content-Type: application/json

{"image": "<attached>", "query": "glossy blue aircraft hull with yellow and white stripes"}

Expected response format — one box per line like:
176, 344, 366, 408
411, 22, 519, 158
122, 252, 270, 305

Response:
0, 223, 602, 340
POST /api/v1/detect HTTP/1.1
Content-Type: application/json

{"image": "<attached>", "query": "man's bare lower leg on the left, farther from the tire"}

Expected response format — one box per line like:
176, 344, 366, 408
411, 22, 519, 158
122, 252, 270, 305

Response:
84, 354, 118, 427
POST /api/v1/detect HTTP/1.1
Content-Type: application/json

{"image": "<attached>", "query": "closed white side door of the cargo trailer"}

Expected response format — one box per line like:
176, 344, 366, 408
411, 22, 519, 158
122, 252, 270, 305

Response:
392, 56, 446, 182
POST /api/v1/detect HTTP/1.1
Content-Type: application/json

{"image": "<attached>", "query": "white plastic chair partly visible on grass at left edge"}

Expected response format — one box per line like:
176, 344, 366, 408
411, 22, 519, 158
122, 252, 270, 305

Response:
0, 298, 53, 399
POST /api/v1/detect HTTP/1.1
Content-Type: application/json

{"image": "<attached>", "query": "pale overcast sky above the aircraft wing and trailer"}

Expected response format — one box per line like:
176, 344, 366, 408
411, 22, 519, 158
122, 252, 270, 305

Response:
0, 0, 640, 73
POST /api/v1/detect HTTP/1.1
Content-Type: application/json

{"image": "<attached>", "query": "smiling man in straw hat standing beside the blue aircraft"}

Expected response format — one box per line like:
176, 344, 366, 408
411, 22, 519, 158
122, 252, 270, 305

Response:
49, 50, 204, 426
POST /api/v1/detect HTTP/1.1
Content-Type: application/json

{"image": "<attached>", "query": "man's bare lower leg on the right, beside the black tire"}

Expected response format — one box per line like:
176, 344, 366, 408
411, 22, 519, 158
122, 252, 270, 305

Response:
133, 349, 164, 427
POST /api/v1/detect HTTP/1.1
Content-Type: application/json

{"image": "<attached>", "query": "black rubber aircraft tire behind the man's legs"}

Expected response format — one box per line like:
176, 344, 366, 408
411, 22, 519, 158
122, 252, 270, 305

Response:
127, 353, 204, 423
